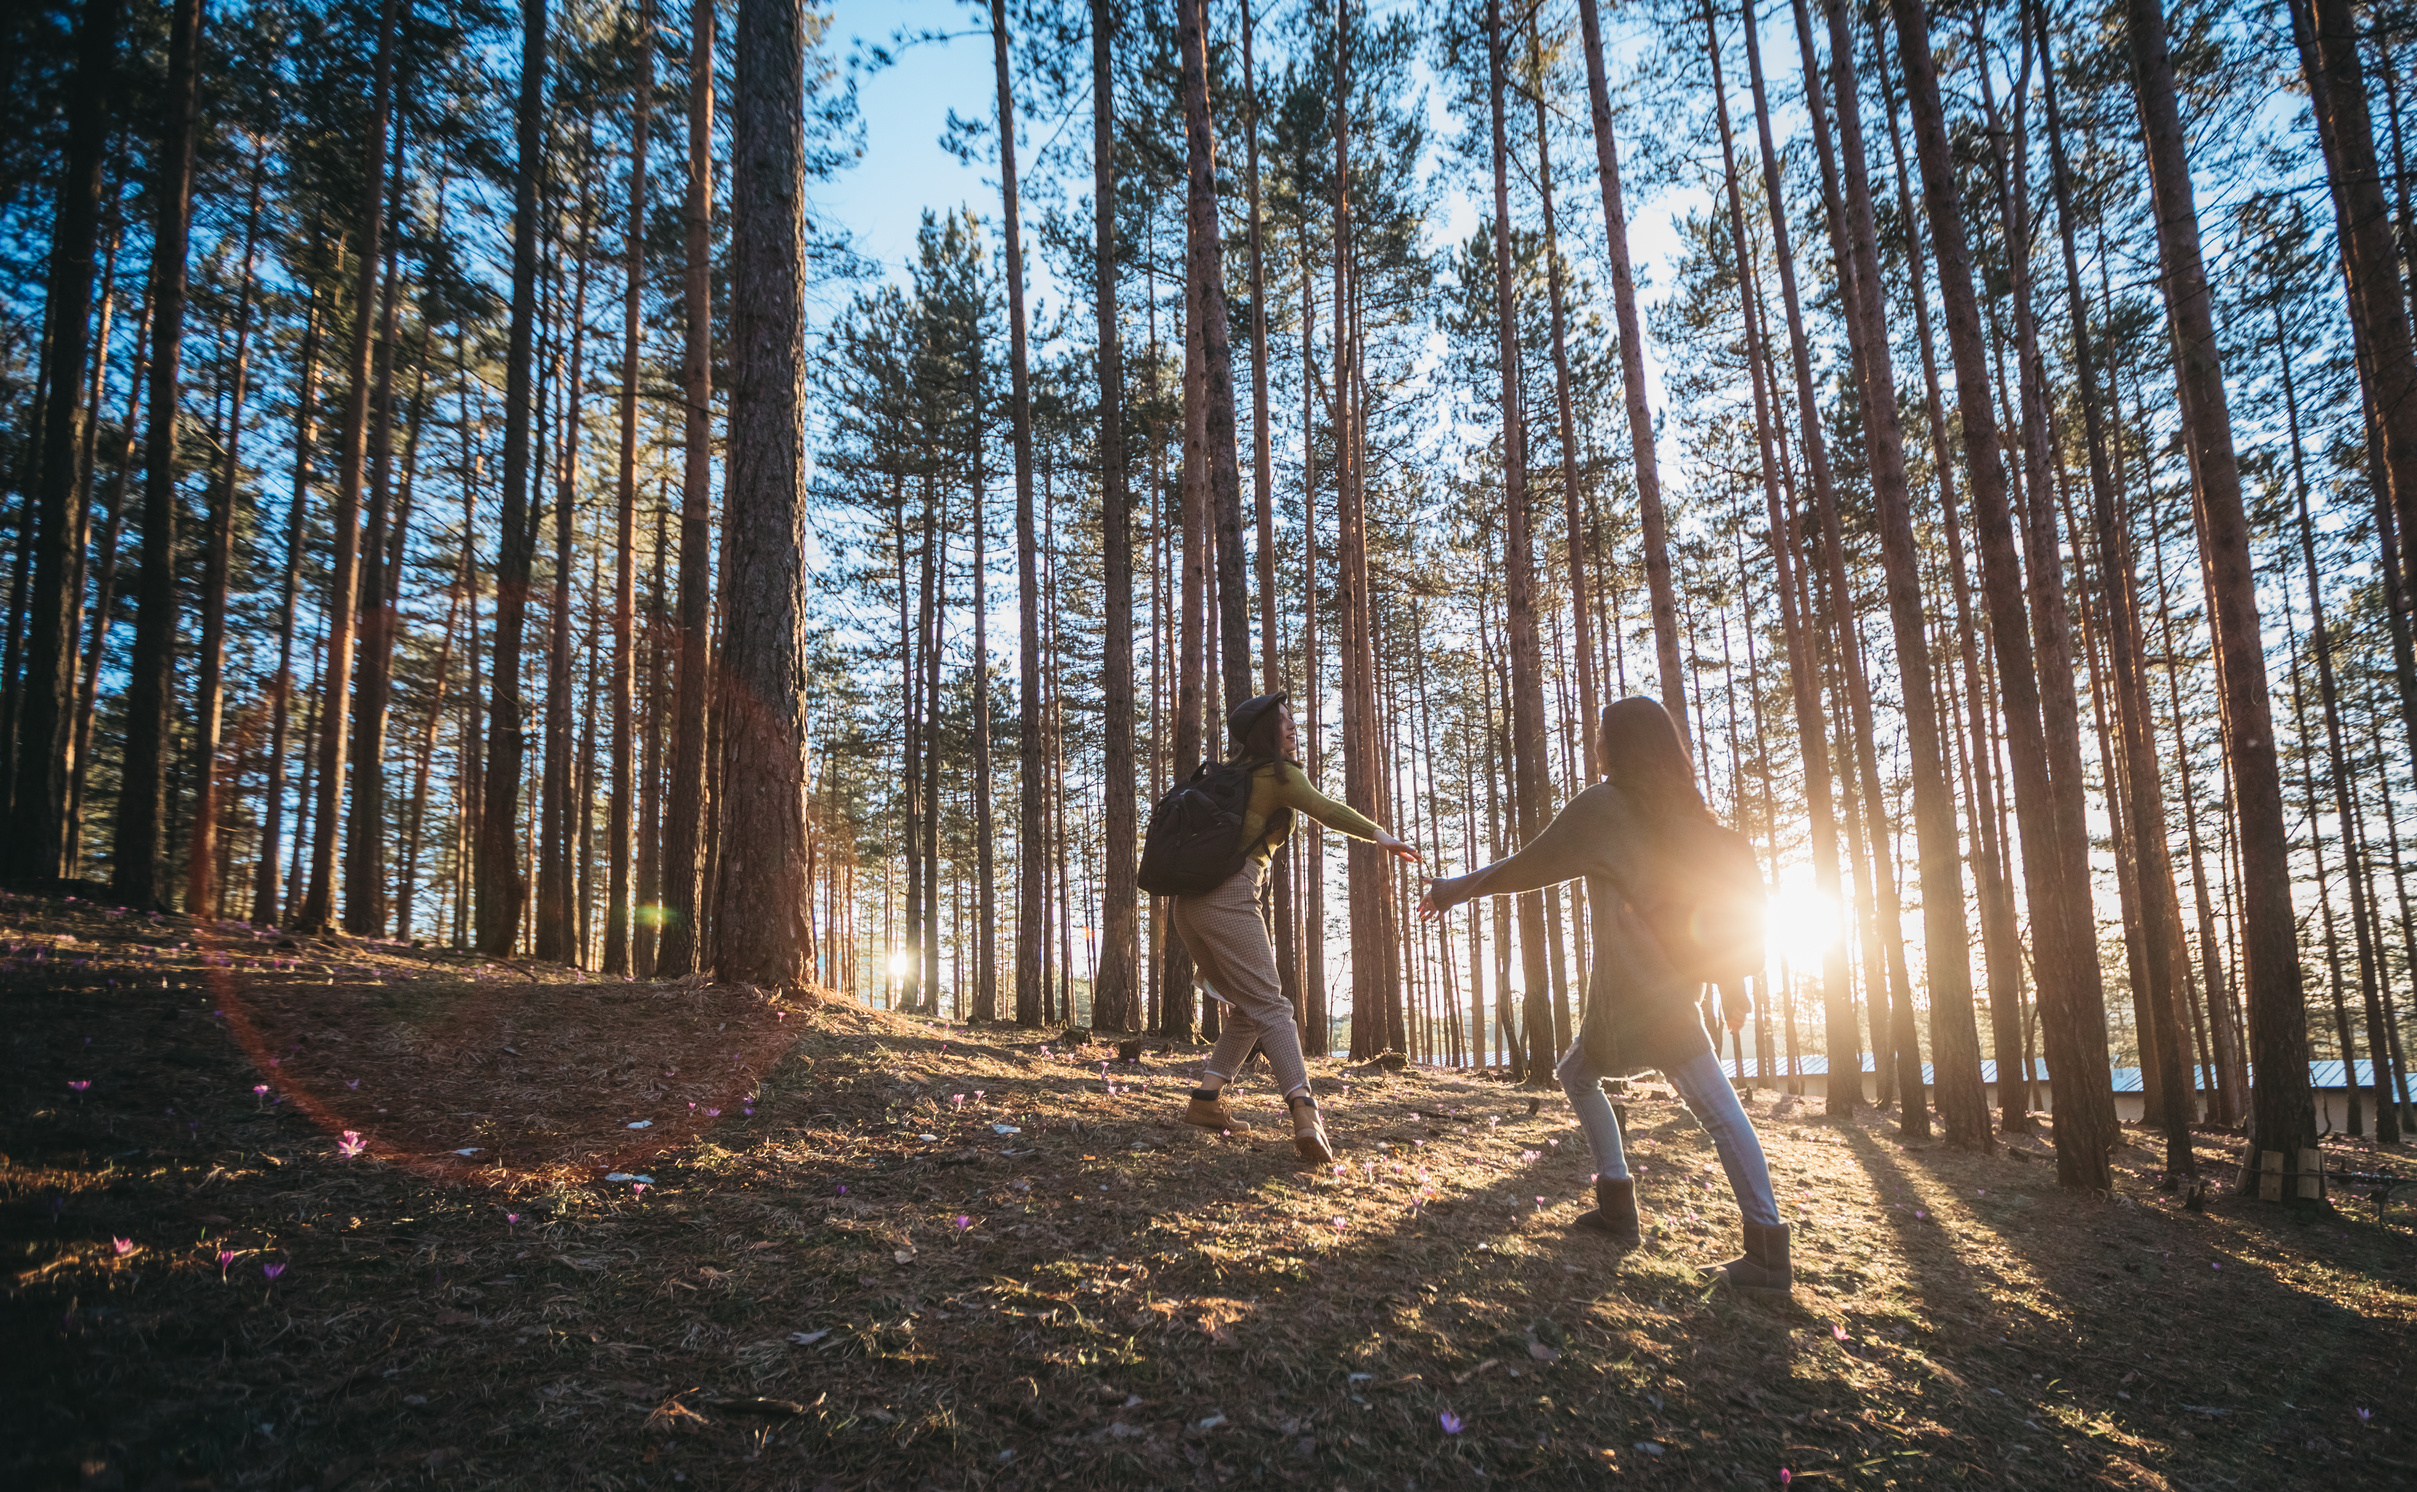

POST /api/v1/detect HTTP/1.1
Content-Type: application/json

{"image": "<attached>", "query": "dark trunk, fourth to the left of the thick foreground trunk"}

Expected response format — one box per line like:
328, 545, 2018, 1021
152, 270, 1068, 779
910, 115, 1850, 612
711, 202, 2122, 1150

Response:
473, 0, 551, 952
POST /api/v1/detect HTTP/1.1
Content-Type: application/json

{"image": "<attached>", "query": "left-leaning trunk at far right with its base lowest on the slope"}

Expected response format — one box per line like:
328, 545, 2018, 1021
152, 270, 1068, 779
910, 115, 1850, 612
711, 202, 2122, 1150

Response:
2126, 0, 2315, 1199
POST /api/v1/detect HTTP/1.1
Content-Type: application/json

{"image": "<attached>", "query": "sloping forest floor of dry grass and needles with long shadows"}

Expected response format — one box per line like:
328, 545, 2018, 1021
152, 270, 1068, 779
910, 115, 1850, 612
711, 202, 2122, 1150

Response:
0, 897, 2417, 1492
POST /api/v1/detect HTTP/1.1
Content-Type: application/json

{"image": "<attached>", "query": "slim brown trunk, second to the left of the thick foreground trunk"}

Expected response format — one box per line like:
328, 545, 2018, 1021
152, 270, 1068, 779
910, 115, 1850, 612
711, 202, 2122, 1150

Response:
604, 0, 655, 975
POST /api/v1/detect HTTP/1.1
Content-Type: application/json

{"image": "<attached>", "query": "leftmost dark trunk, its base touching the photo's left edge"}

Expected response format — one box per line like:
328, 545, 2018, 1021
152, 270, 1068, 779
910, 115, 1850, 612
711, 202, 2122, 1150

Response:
0, 0, 123, 880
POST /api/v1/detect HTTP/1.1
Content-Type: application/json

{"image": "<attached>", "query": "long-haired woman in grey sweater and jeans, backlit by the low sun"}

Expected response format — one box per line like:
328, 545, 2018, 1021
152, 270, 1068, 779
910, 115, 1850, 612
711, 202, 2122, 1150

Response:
1419, 699, 1791, 1294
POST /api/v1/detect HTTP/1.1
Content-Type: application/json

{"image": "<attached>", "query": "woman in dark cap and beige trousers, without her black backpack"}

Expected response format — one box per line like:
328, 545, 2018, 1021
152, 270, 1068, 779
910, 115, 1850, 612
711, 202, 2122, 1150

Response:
1175, 694, 1419, 1161
